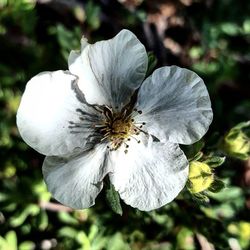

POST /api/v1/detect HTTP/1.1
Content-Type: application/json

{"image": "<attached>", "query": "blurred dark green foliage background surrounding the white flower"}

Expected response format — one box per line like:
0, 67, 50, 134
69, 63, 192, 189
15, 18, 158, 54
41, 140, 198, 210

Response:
0, 0, 250, 250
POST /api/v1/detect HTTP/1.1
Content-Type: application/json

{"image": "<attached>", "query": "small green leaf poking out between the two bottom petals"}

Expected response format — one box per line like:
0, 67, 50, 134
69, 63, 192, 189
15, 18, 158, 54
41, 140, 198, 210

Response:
106, 182, 122, 215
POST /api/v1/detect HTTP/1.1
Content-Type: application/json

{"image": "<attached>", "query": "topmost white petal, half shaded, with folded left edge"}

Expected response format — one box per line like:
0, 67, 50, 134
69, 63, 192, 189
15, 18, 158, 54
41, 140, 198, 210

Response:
68, 30, 148, 107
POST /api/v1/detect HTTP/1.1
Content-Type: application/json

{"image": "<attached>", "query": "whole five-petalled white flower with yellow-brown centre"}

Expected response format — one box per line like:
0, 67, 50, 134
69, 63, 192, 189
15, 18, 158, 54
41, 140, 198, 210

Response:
17, 30, 212, 211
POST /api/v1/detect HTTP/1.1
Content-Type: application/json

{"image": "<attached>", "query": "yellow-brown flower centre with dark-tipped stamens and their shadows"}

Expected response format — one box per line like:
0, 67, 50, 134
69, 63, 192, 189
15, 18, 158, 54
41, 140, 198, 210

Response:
68, 105, 147, 153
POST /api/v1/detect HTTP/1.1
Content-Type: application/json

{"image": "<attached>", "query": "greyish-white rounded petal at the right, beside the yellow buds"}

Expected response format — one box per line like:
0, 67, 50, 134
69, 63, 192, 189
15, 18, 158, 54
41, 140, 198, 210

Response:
136, 66, 213, 144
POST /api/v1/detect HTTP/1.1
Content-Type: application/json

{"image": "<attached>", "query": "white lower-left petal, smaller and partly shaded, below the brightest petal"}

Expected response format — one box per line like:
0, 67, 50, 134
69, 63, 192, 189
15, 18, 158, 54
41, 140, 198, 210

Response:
43, 144, 107, 209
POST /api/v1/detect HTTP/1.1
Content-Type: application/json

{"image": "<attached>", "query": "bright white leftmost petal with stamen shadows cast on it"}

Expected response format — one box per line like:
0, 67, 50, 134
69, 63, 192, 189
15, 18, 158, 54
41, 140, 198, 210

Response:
17, 71, 102, 155
